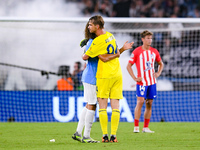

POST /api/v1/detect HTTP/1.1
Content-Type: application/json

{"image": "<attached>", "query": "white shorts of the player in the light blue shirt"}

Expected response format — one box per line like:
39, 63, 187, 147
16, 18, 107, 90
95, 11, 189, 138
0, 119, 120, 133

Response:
83, 82, 97, 105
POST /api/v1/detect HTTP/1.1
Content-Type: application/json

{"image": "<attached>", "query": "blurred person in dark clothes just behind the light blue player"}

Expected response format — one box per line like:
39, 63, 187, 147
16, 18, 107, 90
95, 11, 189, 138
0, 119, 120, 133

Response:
72, 61, 83, 90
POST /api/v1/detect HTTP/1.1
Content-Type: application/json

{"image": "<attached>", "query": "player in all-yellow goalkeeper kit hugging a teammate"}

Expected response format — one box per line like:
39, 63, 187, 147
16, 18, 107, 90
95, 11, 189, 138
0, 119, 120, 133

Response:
82, 15, 133, 142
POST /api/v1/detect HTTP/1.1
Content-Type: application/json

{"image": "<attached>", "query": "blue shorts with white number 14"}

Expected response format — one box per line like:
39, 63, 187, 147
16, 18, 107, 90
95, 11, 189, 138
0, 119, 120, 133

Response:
136, 84, 157, 99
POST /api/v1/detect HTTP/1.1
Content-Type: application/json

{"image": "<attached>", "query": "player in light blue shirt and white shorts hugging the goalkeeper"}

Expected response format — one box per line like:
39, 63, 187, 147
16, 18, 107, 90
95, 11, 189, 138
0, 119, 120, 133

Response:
72, 22, 120, 143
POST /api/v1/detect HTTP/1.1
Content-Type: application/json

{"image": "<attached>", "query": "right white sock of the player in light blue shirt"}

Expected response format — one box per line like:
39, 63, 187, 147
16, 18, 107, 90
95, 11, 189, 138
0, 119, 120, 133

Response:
83, 110, 95, 138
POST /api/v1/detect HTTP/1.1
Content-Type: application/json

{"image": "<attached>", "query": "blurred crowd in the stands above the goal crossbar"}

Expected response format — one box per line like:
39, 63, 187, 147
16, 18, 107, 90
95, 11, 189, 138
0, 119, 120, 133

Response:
66, 0, 200, 18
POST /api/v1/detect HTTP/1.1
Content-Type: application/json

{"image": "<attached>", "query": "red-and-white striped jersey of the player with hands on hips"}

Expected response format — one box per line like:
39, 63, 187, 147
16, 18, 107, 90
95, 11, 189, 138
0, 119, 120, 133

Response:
129, 46, 161, 86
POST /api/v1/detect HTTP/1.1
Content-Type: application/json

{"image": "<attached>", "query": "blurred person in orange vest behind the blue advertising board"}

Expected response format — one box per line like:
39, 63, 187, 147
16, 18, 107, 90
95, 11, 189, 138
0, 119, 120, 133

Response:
57, 66, 74, 91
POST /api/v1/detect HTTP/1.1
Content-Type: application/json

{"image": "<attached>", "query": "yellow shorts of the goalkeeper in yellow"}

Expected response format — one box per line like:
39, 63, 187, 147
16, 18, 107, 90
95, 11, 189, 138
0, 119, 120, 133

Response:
97, 76, 123, 99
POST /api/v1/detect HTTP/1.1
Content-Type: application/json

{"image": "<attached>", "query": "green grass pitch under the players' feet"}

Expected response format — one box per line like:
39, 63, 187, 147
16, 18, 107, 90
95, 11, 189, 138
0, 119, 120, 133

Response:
0, 122, 200, 150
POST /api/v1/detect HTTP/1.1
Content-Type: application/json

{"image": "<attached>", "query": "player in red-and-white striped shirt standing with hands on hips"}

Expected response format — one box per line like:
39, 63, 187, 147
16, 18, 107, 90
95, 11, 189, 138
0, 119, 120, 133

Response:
127, 30, 164, 133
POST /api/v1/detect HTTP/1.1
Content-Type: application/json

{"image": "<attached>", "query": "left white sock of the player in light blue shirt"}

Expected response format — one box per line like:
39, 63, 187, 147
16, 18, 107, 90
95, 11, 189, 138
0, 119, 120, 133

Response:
76, 107, 87, 135
